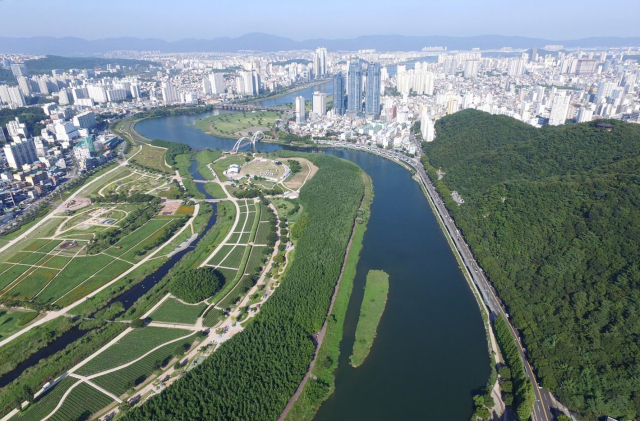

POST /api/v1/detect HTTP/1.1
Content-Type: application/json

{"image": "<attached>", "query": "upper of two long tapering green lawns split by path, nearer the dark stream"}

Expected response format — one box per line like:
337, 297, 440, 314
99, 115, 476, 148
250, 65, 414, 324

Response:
76, 326, 189, 376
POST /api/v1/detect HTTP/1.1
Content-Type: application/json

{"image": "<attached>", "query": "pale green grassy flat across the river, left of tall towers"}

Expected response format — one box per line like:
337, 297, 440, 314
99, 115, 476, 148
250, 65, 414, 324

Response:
196, 111, 284, 137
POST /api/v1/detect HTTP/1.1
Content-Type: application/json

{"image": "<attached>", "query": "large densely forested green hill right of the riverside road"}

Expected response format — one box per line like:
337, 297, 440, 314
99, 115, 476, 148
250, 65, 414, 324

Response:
424, 110, 640, 420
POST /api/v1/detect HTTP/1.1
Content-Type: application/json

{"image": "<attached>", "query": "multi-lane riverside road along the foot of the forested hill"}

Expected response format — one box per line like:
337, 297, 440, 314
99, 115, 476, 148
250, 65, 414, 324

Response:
318, 142, 562, 421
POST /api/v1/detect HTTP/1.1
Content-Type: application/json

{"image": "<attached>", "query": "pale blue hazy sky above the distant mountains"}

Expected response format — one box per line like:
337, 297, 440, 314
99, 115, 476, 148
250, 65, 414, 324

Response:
0, 0, 640, 41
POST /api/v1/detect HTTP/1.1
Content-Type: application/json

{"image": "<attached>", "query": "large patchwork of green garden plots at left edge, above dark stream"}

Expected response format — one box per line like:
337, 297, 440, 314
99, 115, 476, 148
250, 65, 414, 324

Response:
0, 213, 185, 306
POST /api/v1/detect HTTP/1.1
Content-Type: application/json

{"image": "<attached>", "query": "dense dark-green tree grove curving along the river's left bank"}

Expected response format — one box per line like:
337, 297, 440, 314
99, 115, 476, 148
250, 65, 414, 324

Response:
123, 155, 364, 421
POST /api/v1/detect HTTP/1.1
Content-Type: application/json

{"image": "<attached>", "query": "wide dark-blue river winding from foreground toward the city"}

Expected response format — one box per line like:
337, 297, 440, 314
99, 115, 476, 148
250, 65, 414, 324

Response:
136, 83, 489, 421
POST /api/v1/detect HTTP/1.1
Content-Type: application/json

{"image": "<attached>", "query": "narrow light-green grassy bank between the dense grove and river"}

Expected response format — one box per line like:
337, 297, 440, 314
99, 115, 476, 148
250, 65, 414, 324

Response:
279, 173, 374, 421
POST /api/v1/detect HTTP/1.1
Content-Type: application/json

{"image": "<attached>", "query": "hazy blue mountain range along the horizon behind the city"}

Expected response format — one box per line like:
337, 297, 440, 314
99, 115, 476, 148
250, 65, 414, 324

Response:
0, 33, 640, 56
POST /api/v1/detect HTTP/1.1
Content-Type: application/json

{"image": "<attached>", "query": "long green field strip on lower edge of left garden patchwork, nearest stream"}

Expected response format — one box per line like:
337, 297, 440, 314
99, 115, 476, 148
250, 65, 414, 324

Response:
52, 260, 132, 307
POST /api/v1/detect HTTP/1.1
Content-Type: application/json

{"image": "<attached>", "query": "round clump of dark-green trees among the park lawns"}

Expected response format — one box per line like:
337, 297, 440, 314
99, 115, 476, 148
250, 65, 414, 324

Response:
170, 267, 222, 303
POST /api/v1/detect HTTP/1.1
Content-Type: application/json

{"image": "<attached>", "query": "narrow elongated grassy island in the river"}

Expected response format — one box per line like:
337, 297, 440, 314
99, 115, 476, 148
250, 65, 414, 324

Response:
350, 270, 389, 367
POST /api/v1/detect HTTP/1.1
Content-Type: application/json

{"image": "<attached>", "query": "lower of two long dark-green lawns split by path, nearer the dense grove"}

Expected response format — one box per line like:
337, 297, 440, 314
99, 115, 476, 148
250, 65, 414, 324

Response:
92, 332, 195, 396
